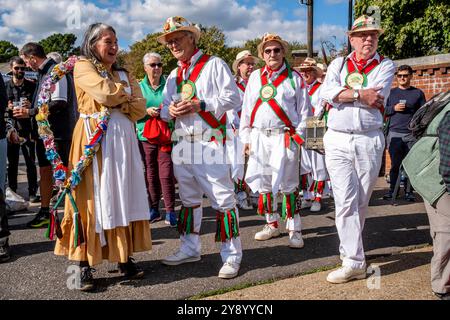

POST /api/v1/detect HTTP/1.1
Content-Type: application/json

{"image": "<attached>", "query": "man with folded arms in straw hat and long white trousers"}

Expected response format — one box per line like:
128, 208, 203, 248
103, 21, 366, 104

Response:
321, 16, 395, 283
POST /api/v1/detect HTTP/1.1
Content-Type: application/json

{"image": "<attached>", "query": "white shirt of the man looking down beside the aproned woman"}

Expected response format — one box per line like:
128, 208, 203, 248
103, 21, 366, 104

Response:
161, 50, 242, 135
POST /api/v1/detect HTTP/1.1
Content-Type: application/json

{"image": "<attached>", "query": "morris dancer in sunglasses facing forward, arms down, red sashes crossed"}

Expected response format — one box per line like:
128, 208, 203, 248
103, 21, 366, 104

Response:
240, 33, 311, 248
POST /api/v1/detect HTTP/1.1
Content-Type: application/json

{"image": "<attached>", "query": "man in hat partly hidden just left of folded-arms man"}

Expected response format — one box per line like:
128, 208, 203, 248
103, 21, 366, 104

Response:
299, 57, 328, 212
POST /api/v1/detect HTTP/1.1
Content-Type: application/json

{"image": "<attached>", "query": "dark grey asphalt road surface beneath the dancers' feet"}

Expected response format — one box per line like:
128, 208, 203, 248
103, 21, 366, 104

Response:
0, 162, 431, 299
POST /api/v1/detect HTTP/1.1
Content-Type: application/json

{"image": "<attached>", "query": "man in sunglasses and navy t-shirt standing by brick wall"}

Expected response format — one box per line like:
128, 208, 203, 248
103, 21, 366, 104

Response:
383, 65, 426, 202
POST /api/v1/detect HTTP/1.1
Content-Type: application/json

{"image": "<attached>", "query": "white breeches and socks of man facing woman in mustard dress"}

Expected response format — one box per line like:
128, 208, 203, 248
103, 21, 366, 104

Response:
172, 140, 242, 263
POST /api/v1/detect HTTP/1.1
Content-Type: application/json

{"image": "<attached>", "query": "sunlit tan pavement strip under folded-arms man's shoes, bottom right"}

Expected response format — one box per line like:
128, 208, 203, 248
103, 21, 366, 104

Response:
206, 246, 438, 300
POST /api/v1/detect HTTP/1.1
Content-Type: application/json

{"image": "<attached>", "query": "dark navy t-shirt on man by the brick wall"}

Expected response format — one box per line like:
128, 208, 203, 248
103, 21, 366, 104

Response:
386, 87, 426, 133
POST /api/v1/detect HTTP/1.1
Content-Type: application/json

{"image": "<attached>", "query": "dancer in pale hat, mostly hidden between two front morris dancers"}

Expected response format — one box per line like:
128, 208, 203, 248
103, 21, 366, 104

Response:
227, 50, 260, 210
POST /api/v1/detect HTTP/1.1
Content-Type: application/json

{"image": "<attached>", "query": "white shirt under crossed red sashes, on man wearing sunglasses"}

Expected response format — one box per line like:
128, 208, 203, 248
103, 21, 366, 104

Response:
239, 63, 312, 143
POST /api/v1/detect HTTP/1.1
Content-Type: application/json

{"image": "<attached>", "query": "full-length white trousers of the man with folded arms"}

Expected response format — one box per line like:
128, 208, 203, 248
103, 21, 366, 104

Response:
324, 130, 385, 268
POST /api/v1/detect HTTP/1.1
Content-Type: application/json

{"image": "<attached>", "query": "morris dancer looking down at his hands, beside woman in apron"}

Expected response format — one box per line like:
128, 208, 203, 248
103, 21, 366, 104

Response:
157, 17, 242, 278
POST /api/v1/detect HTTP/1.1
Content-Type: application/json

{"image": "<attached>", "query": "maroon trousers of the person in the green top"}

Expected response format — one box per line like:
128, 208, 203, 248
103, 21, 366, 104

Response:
139, 141, 175, 212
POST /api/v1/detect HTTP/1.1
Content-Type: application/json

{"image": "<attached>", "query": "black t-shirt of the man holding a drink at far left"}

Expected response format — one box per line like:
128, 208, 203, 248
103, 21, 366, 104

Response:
6, 79, 36, 138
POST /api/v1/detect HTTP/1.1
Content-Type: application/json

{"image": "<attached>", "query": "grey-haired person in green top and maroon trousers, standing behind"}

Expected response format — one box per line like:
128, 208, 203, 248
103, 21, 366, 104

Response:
136, 52, 177, 227
